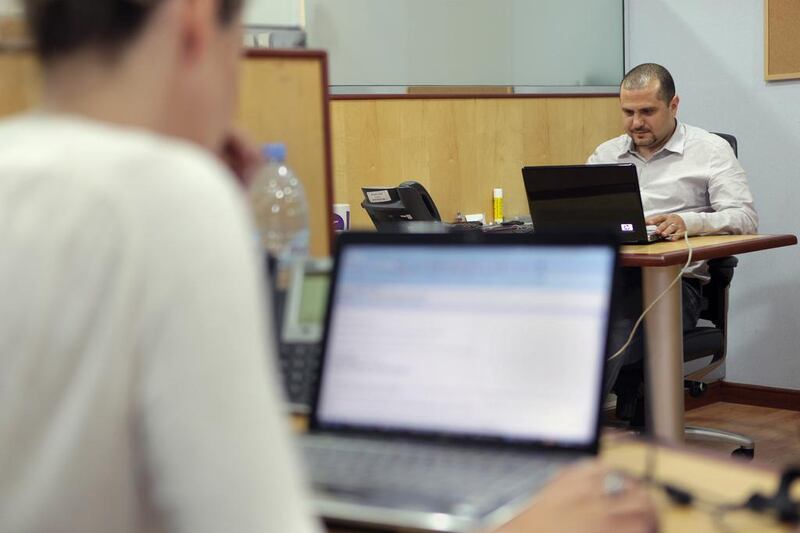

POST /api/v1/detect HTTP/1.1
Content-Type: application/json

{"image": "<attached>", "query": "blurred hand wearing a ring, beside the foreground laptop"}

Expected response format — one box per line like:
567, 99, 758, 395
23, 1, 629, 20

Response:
495, 462, 658, 533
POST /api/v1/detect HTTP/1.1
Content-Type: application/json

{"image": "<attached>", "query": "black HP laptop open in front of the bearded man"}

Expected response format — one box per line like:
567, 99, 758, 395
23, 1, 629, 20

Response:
522, 163, 661, 244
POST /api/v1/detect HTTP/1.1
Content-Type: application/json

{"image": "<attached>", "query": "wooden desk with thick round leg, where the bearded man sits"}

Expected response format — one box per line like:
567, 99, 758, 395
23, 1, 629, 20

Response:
620, 235, 797, 442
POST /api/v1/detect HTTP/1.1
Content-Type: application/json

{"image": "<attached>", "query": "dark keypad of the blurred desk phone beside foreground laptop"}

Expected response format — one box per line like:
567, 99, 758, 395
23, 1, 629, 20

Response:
280, 343, 322, 413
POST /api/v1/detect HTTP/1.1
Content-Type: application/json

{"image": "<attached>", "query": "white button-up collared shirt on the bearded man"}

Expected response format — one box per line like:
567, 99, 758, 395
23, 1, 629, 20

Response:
588, 122, 758, 280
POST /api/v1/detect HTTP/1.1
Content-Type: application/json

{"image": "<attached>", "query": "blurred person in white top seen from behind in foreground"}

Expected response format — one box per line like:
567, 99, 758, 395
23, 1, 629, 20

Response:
0, 0, 655, 533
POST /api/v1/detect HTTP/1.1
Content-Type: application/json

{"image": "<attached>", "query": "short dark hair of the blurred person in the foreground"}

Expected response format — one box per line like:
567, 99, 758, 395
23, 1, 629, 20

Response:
24, 0, 244, 63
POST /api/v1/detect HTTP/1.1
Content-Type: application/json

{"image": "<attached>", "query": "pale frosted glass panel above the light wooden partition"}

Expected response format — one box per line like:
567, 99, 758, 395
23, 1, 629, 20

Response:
306, 0, 624, 87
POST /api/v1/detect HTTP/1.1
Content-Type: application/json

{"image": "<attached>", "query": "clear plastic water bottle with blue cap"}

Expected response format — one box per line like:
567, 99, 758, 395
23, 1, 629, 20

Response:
250, 143, 309, 270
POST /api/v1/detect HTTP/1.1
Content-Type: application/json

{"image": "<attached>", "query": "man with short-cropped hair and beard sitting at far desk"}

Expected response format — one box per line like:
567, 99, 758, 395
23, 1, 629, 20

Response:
588, 63, 758, 417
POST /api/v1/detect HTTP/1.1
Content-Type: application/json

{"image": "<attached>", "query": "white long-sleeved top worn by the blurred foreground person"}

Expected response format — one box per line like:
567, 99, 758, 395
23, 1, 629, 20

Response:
0, 114, 318, 533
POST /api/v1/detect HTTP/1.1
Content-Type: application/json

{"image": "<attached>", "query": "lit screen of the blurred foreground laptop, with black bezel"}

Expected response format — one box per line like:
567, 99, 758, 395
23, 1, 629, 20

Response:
315, 237, 616, 447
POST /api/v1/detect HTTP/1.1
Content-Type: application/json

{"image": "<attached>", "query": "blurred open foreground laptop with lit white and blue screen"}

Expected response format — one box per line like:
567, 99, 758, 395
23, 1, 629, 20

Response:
302, 233, 616, 531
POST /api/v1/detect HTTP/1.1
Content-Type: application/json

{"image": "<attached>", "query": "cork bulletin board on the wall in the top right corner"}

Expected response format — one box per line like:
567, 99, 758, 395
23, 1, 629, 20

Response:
764, 0, 800, 80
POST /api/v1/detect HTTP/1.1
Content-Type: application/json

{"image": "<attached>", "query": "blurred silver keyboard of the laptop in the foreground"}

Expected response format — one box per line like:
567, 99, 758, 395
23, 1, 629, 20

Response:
303, 436, 560, 514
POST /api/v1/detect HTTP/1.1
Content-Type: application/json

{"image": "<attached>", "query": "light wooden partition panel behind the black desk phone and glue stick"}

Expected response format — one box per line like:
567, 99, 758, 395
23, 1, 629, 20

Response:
331, 96, 622, 229
